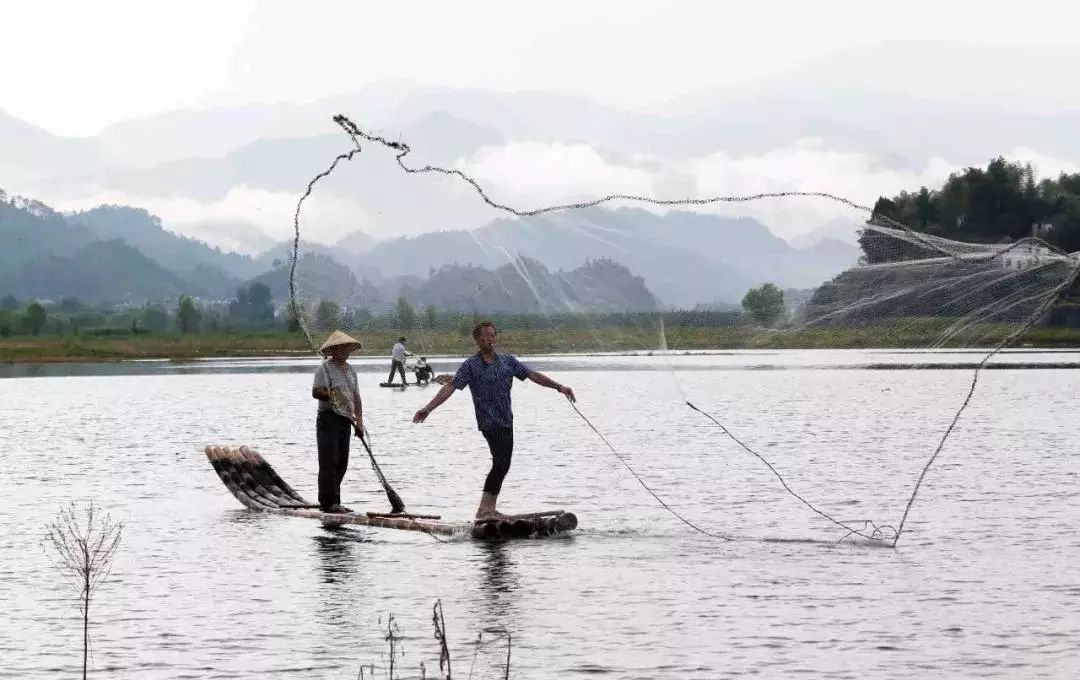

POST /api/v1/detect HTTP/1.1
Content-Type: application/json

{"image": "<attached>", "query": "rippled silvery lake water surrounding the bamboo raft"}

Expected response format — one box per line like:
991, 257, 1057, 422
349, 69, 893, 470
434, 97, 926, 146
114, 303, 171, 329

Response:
0, 351, 1080, 680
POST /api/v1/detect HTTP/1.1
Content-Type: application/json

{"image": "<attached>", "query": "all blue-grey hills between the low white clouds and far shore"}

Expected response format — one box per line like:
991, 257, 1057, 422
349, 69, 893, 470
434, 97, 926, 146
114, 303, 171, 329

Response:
0, 188, 858, 312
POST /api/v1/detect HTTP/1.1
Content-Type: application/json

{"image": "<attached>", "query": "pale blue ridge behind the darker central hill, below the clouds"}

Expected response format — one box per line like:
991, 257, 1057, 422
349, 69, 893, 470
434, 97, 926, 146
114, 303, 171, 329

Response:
328, 208, 860, 308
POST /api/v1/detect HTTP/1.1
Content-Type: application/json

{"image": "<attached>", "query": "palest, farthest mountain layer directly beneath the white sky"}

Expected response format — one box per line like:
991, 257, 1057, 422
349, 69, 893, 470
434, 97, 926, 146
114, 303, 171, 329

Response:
8, 42, 1080, 174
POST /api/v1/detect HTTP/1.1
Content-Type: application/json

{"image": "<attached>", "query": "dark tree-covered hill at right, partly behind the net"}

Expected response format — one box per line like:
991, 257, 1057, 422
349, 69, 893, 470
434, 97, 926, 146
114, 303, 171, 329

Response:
807, 158, 1080, 328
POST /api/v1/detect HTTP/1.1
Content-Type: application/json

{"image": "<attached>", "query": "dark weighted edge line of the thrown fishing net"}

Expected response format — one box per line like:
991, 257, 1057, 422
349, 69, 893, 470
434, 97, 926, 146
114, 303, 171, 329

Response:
288, 114, 1080, 548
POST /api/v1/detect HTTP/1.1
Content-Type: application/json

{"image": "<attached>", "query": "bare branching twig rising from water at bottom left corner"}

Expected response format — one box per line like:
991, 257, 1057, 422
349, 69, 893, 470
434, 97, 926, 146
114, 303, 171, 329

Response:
45, 502, 123, 680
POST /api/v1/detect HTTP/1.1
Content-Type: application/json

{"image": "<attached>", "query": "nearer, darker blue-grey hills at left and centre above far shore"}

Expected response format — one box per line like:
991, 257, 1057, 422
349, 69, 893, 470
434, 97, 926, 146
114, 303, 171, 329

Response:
0, 196, 686, 313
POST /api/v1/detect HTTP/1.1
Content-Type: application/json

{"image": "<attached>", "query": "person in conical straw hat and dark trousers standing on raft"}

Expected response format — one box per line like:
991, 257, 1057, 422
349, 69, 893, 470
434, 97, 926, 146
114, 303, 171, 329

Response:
311, 330, 364, 513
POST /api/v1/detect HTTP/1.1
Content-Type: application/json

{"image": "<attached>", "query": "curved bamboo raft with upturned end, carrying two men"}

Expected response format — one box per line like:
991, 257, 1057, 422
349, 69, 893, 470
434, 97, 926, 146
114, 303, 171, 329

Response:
205, 446, 578, 540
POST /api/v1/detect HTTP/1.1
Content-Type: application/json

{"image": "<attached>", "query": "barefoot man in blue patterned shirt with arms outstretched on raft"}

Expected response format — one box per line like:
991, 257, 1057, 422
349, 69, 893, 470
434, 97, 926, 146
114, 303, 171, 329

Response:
413, 322, 576, 519
